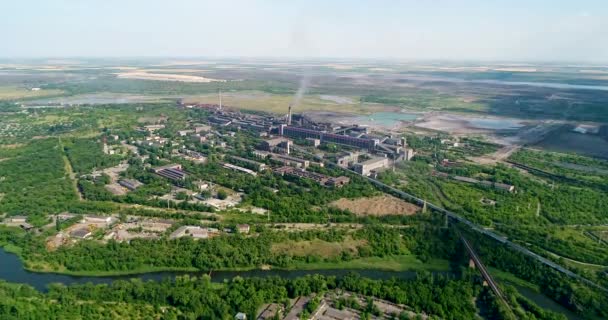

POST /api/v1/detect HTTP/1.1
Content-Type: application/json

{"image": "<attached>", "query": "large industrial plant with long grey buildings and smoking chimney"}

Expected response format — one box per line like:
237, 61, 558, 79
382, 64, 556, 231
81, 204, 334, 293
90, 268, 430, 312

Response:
182, 100, 416, 176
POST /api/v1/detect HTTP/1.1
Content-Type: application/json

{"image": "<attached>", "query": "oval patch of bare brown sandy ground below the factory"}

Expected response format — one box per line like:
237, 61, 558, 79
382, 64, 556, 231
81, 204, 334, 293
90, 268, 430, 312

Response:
331, 196, 419, 216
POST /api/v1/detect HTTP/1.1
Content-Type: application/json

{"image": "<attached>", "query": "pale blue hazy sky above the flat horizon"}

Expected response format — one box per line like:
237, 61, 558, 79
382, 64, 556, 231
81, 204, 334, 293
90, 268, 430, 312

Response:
0, 0, 608, 62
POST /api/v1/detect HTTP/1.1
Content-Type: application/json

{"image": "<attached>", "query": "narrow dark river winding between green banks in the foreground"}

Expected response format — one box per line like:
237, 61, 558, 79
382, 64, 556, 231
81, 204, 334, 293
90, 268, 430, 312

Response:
0, 248, 416, 292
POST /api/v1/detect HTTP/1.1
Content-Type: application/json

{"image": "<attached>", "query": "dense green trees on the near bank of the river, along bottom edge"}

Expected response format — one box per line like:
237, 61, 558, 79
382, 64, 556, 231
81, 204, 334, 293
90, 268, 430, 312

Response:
0, 273, 479, 319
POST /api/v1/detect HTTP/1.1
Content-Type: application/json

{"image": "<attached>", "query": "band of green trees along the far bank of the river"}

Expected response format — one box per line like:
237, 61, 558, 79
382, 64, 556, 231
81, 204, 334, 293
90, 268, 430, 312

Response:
0, 226, 454, 273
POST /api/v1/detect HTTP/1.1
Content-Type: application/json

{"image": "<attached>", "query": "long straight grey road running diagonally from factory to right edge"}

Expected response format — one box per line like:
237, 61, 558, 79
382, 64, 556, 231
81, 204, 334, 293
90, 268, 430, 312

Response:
294, 148, 608, 292
